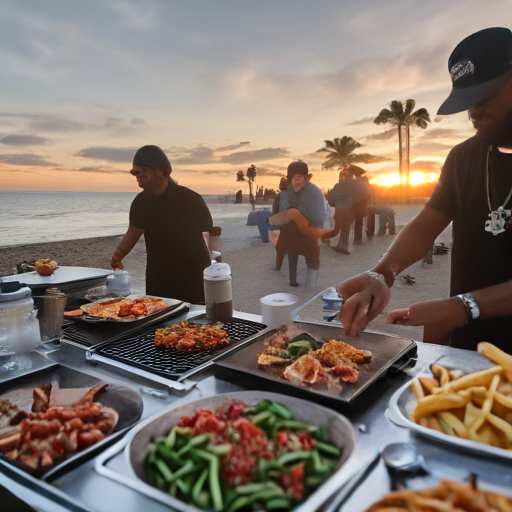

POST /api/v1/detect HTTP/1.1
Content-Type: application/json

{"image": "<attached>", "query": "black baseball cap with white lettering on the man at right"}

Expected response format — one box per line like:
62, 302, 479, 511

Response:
437, 27, 512, 115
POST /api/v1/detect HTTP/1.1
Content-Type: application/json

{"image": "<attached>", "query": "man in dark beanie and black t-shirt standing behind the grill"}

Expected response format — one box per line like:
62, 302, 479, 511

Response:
111, 146, 213, 303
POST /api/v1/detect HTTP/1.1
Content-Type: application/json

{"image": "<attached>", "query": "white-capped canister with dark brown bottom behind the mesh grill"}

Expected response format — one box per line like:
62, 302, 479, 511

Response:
203, 263, 233, 322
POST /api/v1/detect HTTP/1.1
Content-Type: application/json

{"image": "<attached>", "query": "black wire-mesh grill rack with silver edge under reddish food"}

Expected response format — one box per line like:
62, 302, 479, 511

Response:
88, 313, 266, 382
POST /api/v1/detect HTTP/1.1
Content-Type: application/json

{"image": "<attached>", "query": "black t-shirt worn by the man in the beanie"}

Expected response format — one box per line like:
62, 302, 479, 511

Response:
130, 182, 213, 302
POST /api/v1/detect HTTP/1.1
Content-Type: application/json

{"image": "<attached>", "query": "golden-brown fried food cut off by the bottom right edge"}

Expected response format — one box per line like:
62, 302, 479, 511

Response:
366, 480, 512, 512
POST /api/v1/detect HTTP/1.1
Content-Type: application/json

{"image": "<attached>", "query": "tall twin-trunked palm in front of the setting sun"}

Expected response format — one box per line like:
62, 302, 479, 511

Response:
373, 100, 431, 200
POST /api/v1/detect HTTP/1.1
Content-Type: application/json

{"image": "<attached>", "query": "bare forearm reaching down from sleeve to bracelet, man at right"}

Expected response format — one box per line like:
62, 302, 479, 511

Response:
372, 207, 450, 287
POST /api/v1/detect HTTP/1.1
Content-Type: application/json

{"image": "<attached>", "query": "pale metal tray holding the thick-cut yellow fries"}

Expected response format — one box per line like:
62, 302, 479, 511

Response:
389, 354, 512, 462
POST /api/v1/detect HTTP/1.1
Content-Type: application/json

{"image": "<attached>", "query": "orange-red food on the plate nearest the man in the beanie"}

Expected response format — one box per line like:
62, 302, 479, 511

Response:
82, 297, 169, 320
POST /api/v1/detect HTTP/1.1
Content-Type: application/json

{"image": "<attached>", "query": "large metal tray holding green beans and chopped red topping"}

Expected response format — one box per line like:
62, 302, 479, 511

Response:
95, 391, 357, 512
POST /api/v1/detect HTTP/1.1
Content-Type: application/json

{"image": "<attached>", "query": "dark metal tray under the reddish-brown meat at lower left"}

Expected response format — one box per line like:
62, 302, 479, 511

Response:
0, 364, 142, 481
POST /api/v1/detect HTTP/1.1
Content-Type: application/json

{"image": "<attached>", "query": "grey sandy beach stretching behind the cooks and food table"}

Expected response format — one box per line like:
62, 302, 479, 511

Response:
0, 204, 450, 340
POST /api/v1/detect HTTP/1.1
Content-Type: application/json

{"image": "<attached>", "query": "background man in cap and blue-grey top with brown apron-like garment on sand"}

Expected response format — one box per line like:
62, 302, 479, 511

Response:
276, 160, 327, 290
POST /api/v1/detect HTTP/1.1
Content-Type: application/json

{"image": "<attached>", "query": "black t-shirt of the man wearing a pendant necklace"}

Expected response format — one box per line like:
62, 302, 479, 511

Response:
427, 136, 512, 351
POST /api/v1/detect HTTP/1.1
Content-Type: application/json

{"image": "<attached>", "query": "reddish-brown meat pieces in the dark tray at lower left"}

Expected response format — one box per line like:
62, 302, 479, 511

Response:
0, 384, 119, 469
